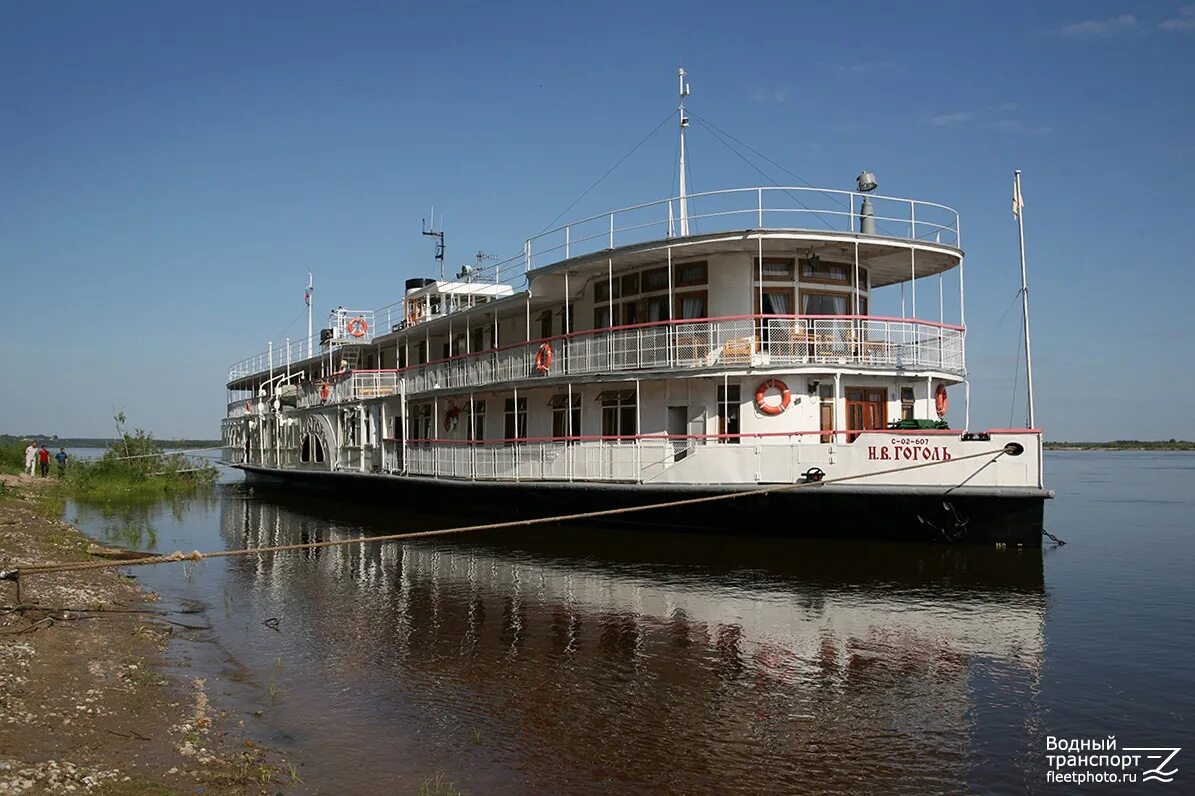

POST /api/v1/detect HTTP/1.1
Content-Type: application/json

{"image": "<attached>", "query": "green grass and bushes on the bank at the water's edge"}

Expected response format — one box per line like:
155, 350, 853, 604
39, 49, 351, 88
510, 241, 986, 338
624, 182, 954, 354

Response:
0, 429, 216, 502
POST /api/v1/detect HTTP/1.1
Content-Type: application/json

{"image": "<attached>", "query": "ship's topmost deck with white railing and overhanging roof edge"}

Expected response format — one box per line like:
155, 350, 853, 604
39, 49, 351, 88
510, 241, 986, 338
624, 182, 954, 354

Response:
228, 186, 962, 387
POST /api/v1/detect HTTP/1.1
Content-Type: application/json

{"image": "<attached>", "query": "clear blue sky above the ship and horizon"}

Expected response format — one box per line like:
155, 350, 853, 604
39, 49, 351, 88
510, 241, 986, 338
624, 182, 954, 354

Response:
0, 1, 1195, 439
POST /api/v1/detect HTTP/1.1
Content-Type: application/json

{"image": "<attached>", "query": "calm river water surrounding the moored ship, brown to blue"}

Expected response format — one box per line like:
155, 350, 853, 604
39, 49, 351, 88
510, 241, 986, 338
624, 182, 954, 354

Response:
67, 452, 1195, 794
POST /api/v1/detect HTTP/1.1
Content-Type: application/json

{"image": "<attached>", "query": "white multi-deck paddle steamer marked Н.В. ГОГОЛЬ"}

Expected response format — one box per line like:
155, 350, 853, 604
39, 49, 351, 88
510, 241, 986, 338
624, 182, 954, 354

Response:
222, 71, 1050, 545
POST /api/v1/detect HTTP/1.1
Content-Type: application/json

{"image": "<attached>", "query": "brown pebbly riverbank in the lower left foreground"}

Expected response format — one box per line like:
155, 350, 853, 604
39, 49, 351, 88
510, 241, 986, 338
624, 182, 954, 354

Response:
0, 476, 300, 794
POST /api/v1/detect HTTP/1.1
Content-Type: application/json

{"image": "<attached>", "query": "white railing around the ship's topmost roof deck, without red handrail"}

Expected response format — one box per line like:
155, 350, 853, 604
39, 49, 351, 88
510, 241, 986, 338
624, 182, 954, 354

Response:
228, 185, 962, 381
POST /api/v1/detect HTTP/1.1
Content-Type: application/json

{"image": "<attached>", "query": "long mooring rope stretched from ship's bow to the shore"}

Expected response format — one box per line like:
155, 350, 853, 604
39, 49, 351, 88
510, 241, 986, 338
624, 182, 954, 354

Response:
7, 446, 1012, 580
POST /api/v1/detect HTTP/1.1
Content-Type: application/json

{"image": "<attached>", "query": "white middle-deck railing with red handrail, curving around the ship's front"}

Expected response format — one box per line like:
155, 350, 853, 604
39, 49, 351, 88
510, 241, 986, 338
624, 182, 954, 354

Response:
402, 316, 966, 394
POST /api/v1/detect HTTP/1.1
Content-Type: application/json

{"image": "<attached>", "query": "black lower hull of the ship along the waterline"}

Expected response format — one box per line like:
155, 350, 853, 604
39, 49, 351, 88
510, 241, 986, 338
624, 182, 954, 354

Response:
240, 465, 1052, 546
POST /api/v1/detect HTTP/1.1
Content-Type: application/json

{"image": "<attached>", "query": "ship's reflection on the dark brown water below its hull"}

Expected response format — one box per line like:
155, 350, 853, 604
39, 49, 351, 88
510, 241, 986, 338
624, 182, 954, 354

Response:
221, 492, 1046, 792
